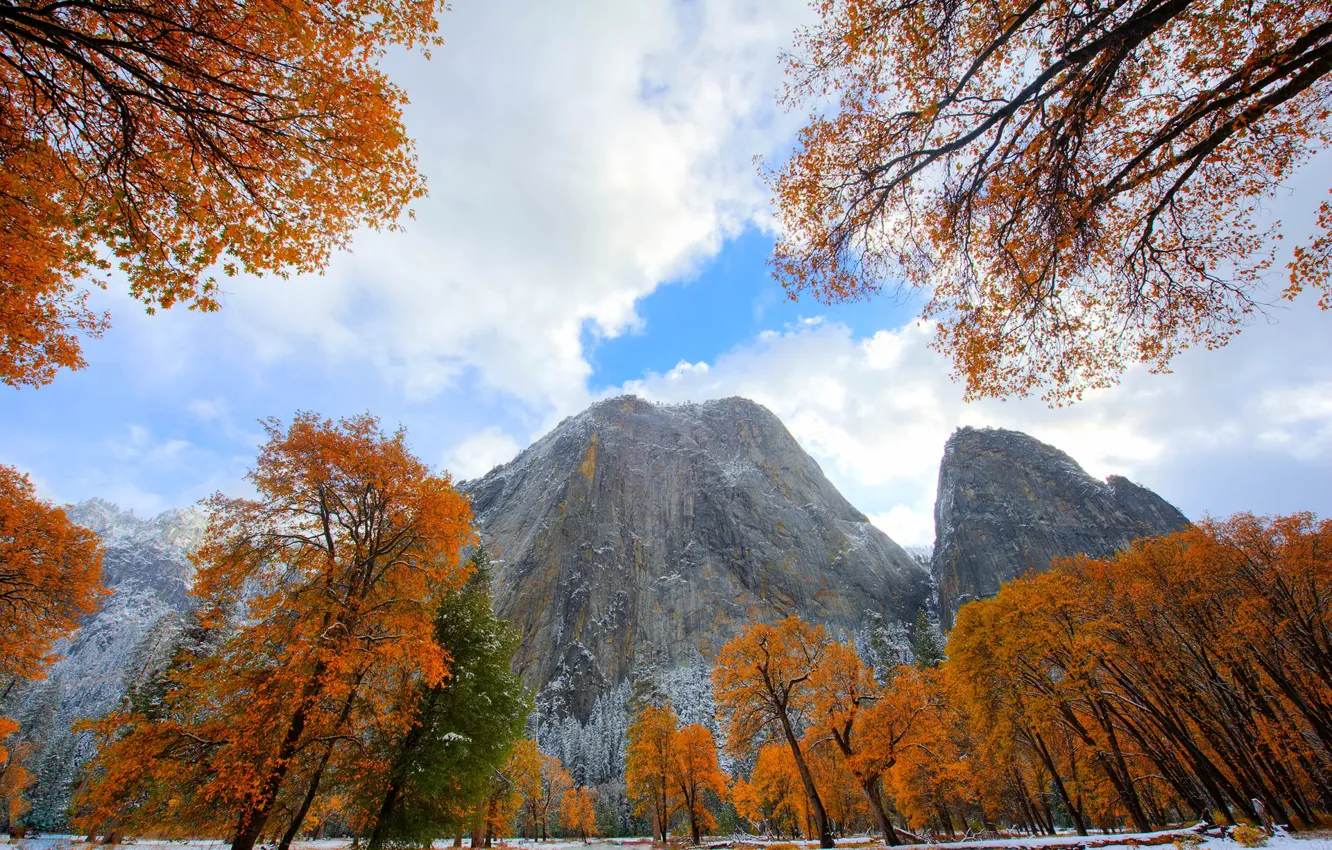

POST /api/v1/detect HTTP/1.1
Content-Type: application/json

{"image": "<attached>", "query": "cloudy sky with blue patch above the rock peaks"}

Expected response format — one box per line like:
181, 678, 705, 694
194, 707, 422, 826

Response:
0, 0, 1332, 545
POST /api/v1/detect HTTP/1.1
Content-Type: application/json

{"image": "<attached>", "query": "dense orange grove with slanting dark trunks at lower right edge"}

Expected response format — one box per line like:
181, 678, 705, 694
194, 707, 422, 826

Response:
932, 514, 1332, 833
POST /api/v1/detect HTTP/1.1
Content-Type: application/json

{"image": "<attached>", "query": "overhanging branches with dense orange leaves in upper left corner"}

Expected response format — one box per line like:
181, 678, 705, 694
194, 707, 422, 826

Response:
0, 0, 446, 386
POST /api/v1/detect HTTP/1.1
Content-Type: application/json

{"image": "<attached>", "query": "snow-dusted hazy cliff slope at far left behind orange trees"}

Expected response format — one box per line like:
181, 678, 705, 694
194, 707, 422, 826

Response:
0, 500, 204, 830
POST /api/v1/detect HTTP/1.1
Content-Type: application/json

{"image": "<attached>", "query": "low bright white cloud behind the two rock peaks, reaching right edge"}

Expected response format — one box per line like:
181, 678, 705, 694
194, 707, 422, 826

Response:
615, 295, 1332, 545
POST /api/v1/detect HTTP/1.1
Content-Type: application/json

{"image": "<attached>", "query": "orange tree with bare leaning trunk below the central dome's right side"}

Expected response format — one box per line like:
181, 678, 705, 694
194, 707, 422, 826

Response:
713, 617, 833, 847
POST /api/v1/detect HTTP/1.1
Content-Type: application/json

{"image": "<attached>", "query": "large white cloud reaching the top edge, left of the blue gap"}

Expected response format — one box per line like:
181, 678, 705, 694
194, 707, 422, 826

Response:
207, 0, 809, 412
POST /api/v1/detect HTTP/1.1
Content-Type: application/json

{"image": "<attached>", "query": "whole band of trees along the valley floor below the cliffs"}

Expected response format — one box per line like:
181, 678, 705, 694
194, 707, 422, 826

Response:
0, 414, 1332, 850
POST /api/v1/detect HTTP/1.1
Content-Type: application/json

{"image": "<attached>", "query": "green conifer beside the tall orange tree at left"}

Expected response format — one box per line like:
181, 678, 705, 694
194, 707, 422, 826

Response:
369, 546, 531, 850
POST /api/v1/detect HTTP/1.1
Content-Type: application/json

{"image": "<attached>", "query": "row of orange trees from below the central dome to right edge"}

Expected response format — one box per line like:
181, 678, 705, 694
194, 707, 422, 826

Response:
612, 514, 1332, 846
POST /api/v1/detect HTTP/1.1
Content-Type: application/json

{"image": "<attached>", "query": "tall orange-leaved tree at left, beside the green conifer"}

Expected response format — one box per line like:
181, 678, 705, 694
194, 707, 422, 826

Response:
80, 413, 472, 850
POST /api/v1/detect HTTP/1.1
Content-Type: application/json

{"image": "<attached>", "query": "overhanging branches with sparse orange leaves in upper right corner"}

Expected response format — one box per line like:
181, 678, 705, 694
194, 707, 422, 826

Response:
770, 0, 1332, 402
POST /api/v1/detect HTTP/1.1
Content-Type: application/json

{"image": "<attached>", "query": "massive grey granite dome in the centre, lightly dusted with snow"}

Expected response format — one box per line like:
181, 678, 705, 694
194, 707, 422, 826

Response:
464, 397, 930, 718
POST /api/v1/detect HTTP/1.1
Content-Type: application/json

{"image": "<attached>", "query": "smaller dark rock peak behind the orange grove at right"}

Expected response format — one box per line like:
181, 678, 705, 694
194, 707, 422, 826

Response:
931, 428, 1188, 628
